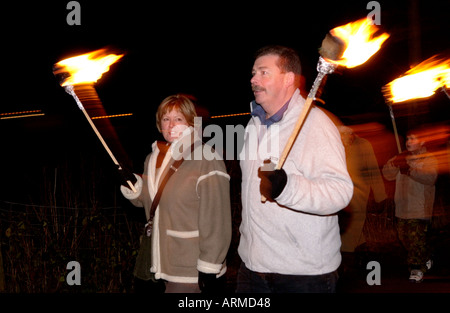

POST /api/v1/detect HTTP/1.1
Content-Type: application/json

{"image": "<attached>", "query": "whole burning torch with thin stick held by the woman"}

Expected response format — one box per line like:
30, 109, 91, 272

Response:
53, 49, 136, 192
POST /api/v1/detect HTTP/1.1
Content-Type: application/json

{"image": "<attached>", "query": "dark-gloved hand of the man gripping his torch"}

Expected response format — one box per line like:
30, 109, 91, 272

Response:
258, 160, 287, 201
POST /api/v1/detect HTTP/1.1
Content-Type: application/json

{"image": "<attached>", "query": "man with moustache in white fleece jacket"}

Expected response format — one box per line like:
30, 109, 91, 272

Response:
237, 46, 353, 292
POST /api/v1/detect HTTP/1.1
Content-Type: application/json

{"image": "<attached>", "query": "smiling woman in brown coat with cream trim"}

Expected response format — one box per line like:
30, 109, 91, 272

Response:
121, 94, 231, 293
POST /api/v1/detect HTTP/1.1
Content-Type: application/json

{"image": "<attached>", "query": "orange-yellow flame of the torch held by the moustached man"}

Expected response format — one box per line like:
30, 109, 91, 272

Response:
329, 18, 389, 68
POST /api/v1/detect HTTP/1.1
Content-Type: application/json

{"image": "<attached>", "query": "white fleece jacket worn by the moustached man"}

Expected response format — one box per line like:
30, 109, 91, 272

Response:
238, 90, 353, 275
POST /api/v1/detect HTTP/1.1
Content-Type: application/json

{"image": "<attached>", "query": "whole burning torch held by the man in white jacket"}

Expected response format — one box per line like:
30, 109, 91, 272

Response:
262, 18, 389, 202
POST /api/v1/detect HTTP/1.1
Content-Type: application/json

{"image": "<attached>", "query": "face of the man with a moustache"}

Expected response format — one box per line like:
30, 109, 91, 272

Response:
250, 55, 285, 111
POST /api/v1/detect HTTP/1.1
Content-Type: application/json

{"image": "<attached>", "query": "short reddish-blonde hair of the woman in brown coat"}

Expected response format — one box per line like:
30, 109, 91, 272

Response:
156, 94, 197, 132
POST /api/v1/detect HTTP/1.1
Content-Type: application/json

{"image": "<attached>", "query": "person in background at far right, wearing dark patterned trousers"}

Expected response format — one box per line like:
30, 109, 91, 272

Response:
382, 128, 438, 282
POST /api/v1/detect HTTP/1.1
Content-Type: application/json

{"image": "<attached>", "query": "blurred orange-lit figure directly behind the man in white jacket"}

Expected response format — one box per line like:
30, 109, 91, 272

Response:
338, 125, 387, 252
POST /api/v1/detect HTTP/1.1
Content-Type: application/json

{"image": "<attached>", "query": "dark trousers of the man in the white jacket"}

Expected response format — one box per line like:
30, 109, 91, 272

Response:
236, 262, 338, 293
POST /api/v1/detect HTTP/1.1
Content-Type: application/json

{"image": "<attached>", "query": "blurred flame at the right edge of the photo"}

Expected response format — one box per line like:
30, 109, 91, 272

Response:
383, 55, 450, 102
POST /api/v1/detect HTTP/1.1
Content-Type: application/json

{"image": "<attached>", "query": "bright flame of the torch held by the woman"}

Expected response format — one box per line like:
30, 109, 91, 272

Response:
55, 49, 123, 87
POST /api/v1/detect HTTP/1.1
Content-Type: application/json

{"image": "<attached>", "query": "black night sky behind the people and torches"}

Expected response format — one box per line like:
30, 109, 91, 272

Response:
0, 0, 450, 202
